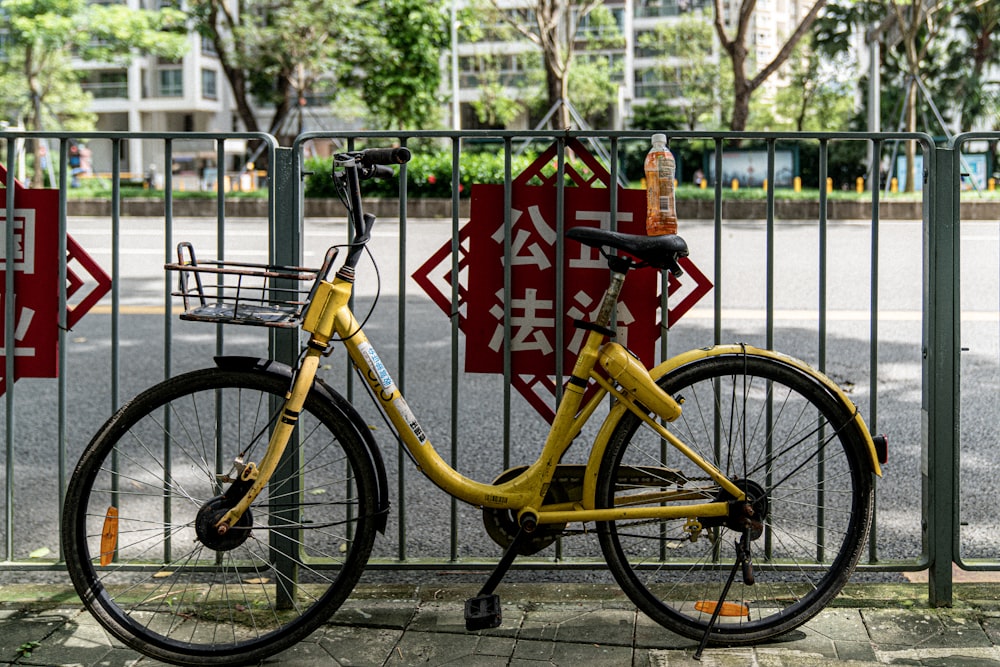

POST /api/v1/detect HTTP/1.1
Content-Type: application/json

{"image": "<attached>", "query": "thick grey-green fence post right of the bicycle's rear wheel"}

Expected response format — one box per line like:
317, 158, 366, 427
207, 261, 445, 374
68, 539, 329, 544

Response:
921, 146, 961, 607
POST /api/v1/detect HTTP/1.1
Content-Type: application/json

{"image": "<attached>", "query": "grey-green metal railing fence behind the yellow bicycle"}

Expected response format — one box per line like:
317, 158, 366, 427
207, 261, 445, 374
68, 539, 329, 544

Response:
0, 132, 1000, 604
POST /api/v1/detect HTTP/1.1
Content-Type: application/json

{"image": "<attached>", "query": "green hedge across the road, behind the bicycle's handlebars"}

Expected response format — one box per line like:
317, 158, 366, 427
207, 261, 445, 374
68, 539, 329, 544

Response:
305, 148, 537, 198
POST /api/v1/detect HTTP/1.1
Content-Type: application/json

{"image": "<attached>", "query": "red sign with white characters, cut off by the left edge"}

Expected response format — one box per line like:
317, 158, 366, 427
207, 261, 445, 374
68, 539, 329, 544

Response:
0, 166, 111, 395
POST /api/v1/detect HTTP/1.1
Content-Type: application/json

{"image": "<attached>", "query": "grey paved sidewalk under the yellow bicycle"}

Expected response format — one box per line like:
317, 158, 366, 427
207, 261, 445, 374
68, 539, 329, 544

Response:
0, 584, 1000, 667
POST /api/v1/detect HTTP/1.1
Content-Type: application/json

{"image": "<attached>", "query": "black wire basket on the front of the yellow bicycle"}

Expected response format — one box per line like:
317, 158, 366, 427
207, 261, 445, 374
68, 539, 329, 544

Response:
164, 242, 336, 328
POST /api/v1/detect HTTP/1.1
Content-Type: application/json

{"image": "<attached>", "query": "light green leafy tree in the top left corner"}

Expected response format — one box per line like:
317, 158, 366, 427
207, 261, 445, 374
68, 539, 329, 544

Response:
0, 0, 187, 182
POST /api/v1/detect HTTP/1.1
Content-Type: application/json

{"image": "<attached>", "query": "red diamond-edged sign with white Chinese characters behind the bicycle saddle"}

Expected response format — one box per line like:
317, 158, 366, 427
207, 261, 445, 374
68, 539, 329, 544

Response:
413, 140, 711, 421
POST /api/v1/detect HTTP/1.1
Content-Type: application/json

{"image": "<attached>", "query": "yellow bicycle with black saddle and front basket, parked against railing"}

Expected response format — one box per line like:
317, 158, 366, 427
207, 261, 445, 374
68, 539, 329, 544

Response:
62, 148, 886, 665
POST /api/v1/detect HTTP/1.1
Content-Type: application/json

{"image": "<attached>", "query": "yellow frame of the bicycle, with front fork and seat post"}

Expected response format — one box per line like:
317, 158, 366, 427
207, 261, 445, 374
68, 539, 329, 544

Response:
219, 250, 746, 530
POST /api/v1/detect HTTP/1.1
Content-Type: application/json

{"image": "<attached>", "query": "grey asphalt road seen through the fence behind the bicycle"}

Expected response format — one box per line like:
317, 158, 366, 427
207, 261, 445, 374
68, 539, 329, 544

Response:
0, 218, 1000, 580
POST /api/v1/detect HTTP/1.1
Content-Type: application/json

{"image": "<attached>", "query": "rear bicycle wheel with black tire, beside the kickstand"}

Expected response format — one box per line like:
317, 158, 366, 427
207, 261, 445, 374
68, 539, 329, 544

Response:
596, 354, 873, 645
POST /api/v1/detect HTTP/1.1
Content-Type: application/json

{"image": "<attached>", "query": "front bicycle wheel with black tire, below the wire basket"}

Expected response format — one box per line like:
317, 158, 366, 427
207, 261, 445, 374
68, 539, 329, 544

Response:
62, 368, 378, 665
